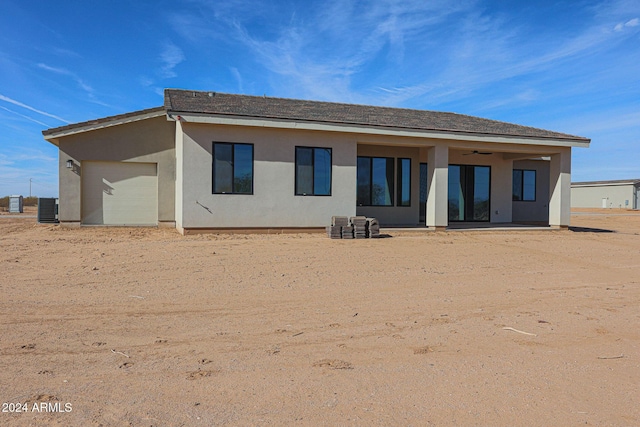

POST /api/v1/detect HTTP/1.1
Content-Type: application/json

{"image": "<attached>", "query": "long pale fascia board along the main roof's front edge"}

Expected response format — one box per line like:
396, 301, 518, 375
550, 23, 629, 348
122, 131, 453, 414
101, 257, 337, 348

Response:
168, 111, 589, 147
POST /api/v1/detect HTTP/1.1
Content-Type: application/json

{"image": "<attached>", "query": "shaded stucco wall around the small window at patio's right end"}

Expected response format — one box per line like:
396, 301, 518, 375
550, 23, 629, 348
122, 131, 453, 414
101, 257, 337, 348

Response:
513, 160, 549, 222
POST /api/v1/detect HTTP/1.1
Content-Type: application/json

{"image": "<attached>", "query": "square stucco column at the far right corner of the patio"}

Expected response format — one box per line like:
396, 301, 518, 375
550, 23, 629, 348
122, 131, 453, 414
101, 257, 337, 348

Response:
549, 147, 571, 228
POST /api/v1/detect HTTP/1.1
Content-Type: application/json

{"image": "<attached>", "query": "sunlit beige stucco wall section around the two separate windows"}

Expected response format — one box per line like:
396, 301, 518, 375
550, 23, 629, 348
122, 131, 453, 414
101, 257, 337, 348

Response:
178, 123, 356, 229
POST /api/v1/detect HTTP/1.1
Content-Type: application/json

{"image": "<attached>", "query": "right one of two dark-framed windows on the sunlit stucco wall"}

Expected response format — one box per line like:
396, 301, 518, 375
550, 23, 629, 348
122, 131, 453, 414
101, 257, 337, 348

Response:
295, 147, 331, 196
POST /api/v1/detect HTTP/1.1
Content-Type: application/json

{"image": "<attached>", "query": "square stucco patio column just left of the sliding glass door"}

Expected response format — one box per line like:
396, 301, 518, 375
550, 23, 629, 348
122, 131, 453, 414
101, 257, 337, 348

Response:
426, 144, 449, 230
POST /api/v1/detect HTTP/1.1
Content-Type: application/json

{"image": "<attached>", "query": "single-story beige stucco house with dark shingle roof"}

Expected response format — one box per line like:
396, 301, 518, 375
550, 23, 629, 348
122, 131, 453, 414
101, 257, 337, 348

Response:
43, 89, 590, 233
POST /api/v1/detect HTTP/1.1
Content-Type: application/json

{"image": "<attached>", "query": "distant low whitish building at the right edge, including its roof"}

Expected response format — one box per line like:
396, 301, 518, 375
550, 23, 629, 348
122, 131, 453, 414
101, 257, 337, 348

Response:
571, 179, 640, 209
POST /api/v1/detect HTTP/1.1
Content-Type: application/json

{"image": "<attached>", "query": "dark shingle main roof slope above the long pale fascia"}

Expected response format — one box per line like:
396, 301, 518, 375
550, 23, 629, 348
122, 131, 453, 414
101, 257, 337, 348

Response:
164, 89, 590, 143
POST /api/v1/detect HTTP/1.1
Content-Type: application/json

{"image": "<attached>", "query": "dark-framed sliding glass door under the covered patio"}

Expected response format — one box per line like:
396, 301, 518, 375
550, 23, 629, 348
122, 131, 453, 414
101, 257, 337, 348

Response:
449, 165, 491, 221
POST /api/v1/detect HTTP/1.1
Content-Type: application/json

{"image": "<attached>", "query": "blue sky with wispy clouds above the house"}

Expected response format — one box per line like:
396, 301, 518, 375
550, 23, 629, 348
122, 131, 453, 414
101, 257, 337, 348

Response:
0, 0, 640, 197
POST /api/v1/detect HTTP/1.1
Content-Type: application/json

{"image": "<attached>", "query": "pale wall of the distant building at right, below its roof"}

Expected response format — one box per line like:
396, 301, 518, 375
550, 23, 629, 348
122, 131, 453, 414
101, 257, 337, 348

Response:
571, 184, 638, 209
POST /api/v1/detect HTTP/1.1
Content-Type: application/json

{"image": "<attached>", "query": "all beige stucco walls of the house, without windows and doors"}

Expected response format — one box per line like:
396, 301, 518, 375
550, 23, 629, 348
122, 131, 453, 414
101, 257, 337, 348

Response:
53, 111, 571, 229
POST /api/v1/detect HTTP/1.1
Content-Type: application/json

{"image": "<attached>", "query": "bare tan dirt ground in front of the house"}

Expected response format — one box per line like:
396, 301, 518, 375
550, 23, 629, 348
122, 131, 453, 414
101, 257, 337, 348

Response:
0, 211, 640, 426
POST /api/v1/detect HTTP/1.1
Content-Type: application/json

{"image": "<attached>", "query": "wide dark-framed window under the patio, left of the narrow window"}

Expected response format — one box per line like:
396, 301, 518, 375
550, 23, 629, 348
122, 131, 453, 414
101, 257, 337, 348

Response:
356, 156, 394, 206
